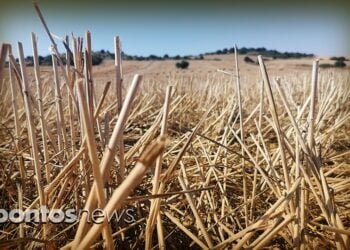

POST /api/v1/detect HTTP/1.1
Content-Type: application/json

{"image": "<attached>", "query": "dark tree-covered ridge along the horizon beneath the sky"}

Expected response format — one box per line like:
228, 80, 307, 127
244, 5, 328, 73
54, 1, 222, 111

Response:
26, 47, 314, 66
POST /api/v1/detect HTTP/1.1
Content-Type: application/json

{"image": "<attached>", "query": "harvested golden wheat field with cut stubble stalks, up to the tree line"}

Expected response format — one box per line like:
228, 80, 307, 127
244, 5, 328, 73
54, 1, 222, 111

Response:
0, 2, 350, 249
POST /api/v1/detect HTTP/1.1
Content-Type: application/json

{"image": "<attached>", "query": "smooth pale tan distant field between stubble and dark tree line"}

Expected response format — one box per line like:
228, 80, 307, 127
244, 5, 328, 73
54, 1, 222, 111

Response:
94, 54, 349, 77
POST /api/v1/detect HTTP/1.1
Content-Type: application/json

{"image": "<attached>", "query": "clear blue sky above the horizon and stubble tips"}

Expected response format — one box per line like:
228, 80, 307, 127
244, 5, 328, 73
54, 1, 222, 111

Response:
0, 0, 350, 56
